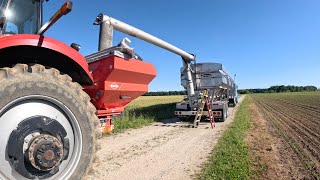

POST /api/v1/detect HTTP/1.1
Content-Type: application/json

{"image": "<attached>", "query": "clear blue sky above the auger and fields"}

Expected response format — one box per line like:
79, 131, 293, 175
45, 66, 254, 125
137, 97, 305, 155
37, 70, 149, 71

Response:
45, 0, 320, 91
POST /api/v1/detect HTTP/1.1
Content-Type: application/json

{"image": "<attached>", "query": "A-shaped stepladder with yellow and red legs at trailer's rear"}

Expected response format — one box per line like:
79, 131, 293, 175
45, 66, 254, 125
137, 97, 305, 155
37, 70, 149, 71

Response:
193, 89, 215, 128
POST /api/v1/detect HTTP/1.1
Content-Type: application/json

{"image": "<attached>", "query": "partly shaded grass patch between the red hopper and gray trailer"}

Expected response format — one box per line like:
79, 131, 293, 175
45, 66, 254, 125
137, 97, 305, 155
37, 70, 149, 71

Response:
113, 96, 183, 133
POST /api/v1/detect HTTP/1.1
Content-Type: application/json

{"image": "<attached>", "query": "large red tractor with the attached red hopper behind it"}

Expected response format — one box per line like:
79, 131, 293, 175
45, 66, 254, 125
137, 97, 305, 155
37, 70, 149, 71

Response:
0, 0, 156, 179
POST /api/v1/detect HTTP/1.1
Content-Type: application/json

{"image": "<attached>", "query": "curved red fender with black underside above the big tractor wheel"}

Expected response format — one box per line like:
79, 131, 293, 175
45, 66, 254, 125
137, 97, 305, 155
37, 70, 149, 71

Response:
0, 34, 93, 85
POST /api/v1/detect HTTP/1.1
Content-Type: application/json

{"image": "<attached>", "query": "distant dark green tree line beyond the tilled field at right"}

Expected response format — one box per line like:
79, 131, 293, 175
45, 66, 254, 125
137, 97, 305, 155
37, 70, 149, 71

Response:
238, 85, 318, 94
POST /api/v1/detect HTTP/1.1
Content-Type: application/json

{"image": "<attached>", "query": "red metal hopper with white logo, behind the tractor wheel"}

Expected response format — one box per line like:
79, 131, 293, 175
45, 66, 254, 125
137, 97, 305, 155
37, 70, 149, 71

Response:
84, 56, 156, 112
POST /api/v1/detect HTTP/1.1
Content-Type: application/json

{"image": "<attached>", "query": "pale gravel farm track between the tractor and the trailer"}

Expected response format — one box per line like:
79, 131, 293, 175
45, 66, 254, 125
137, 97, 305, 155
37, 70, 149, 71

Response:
89, 99, 242, 179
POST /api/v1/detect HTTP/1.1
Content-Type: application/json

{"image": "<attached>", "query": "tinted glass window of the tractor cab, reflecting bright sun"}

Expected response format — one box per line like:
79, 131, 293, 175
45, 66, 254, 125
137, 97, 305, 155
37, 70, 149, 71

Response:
3, 0, 39, 34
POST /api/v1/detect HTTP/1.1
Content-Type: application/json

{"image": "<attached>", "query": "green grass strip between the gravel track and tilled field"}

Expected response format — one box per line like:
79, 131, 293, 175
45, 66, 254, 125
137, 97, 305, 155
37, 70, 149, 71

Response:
199, 97, 251, 180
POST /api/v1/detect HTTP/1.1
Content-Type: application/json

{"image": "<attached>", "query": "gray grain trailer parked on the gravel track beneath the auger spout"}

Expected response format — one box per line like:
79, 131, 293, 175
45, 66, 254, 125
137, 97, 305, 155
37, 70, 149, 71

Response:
175, 63, 237, 121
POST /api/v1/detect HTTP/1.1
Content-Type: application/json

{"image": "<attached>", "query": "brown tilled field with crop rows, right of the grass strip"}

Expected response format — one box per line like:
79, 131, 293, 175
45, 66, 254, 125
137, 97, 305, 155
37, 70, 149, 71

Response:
252, 93, 320, 179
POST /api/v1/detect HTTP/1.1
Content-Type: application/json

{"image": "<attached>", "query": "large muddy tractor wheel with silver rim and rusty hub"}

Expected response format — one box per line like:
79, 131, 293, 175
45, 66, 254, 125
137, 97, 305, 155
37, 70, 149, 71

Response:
0, 64, 98, 179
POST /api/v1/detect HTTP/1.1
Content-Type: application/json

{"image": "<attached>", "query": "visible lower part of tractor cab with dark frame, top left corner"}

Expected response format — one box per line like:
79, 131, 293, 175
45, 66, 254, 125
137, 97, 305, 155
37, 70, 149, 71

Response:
0, 0, 42, 34
